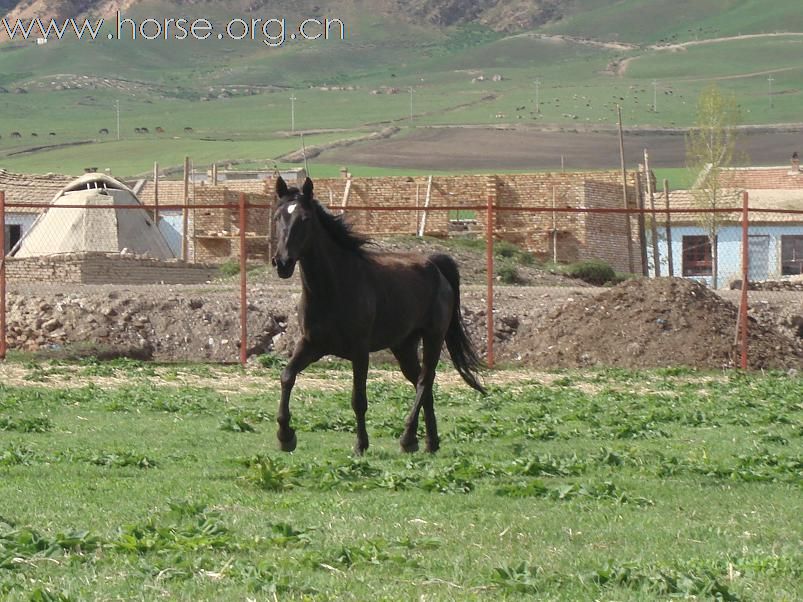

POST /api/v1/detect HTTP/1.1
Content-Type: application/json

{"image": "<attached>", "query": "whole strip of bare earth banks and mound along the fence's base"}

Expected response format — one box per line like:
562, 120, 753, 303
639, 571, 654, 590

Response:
8, 276, 803, 369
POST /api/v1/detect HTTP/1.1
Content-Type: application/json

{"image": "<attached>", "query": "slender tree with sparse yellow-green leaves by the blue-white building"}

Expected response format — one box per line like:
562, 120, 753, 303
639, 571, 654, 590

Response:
686, 84, 746, 288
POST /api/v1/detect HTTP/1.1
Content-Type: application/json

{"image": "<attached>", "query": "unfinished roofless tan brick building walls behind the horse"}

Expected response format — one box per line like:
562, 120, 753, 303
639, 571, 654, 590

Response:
177, 171, 641, 271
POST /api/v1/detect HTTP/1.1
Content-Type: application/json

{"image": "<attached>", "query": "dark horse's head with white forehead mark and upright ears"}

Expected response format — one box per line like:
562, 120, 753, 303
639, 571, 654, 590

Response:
273, 176, 315, 278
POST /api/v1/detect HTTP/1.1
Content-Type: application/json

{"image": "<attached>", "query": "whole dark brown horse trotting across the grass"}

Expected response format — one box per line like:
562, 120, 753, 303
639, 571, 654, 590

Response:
273, 178, 484, 454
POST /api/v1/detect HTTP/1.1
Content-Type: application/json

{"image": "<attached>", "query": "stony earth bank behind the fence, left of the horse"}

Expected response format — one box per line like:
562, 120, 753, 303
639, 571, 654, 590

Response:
7, 285, 300, 362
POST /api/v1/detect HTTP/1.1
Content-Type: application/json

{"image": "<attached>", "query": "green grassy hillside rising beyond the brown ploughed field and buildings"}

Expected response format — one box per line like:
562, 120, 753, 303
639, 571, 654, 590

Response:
0, 0, 803, 175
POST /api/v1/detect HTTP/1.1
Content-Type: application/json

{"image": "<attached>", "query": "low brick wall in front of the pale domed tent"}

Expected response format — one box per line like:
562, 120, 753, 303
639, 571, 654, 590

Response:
6, 253, 217, 284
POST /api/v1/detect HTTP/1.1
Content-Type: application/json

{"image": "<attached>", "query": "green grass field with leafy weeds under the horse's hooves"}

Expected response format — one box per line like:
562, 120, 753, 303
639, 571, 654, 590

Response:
0, 358, 803, 601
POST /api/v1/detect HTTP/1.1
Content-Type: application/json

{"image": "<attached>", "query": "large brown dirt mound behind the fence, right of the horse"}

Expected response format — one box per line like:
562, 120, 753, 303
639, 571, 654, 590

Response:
516, 278, 803, 369
